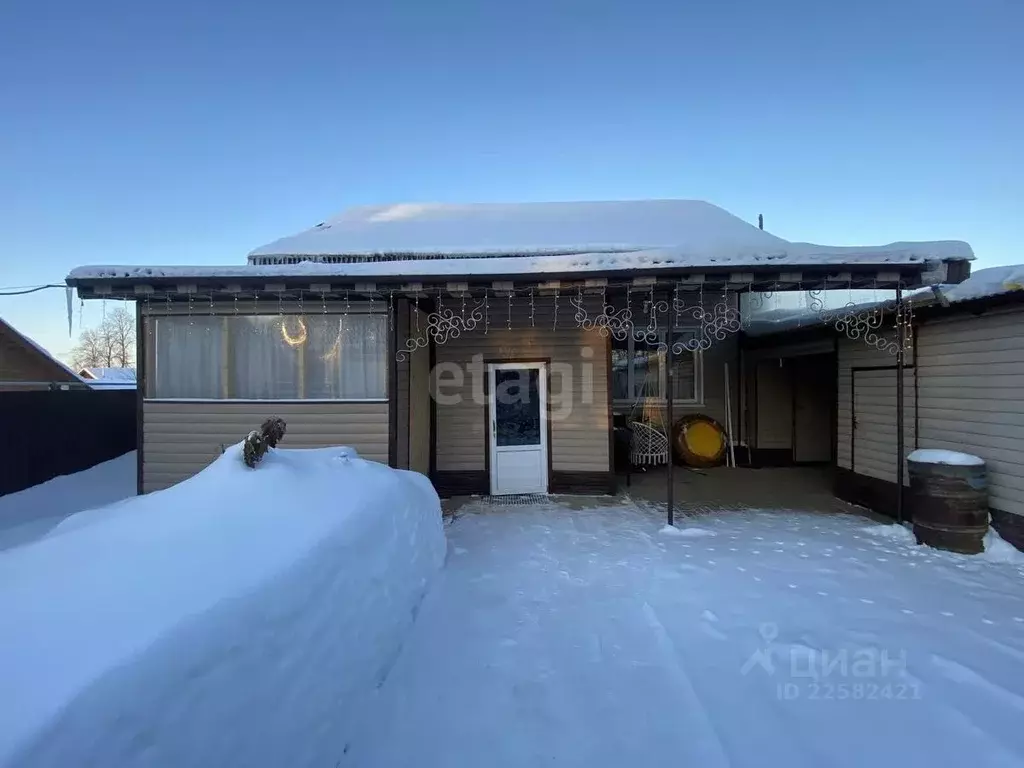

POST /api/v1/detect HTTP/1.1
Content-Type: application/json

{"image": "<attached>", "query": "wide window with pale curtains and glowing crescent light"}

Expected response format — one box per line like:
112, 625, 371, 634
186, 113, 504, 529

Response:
146, 314, 387, 400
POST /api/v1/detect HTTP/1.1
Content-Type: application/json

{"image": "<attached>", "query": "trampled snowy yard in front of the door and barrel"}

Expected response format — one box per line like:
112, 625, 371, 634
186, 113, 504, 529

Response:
345, 507, 1024, 768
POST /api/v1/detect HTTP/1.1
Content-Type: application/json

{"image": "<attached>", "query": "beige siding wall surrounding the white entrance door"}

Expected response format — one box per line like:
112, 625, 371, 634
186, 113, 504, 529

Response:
434, 297, 610, 472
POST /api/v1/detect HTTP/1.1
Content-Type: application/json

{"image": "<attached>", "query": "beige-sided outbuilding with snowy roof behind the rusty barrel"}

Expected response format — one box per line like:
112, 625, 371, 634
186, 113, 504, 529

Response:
744, 265, 1024, 548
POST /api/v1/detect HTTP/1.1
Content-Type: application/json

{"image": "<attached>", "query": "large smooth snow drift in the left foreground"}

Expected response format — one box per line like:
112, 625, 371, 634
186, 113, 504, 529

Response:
0, 447, 445, 768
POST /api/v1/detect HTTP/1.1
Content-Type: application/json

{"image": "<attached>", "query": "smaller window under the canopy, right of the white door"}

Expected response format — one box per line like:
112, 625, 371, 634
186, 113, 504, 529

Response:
611, 331, 701, 402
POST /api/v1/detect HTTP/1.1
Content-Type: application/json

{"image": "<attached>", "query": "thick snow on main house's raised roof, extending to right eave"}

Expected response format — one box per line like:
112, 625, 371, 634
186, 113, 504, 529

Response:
250, 200, 974, 268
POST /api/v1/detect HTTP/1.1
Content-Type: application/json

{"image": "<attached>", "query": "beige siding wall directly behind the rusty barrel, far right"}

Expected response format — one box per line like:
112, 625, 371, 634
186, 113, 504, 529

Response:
918, 309, 1024, 514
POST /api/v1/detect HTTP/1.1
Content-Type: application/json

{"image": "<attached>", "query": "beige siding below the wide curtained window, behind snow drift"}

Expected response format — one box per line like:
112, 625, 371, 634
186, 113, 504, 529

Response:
142, 400, 388, 493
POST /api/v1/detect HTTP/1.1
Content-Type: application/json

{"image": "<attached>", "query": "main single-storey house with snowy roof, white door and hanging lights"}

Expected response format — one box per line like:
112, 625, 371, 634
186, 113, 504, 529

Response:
59, 200, 973, 518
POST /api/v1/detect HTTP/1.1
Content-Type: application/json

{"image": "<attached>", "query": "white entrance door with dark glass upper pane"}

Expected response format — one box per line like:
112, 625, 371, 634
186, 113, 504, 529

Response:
487, 362, 548, 496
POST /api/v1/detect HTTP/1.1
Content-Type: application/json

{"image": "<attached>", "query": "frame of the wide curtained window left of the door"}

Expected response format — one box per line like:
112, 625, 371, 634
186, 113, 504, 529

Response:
139, 305, 392, 403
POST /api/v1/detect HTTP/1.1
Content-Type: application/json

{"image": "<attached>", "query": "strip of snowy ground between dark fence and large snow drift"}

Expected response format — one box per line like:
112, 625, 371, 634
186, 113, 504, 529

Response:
0, 451, 136, 550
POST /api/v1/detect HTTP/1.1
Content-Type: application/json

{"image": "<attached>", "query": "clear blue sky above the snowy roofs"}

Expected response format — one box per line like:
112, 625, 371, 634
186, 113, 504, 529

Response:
0, 0, 1024, 354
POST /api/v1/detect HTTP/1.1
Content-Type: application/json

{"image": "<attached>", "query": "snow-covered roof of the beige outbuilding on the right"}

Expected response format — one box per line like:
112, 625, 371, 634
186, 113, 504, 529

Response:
745, 264, 1024, 336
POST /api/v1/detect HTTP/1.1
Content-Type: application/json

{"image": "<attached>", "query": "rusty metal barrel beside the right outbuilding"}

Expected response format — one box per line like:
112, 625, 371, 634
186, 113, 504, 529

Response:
907, 460, 988, 555
